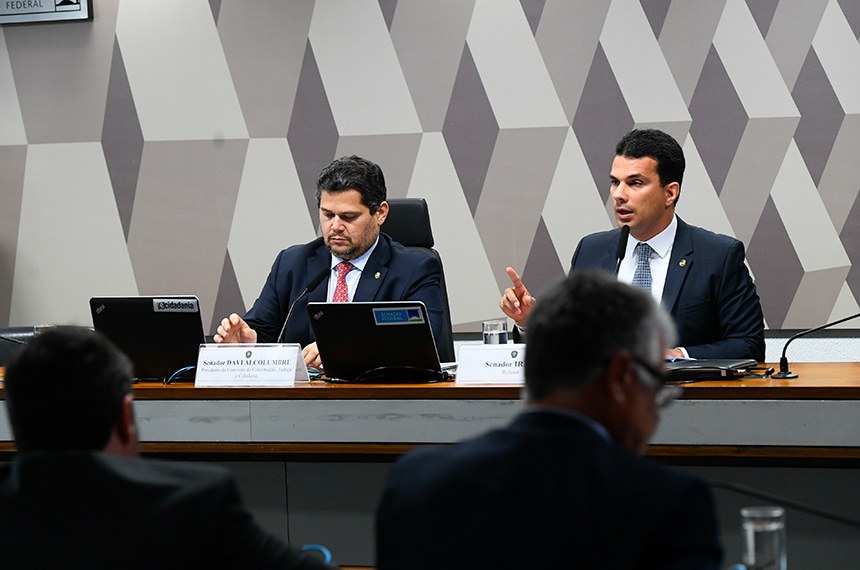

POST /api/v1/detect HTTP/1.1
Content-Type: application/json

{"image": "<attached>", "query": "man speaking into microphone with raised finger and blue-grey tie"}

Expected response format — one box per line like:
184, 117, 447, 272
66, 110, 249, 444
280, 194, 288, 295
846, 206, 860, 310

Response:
499, 129, 765, 361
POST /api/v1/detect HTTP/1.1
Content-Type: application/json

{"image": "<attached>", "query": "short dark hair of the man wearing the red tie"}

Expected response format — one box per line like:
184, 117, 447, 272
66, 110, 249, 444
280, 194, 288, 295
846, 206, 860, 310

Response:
316, 154, 388, 214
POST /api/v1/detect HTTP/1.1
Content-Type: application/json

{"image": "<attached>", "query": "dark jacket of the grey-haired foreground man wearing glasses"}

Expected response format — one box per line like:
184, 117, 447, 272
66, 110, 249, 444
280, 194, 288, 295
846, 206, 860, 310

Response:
376, 410, 722, 570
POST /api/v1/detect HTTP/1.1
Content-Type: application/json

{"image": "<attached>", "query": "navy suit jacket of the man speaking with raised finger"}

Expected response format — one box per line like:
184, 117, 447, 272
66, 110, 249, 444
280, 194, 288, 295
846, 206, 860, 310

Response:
570, 218, 764, 362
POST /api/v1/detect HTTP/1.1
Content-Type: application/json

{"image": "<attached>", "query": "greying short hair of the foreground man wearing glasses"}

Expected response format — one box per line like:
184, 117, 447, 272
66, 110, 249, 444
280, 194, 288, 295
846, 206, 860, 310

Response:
525, 270, 675, 399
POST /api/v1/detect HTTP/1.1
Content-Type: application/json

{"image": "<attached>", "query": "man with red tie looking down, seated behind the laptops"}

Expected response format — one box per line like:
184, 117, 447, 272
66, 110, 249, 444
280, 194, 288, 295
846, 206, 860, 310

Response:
215, 156, 443, 366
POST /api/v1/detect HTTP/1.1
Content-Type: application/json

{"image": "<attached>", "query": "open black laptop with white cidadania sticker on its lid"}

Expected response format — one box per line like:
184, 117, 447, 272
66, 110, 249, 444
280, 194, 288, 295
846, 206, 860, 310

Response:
90, 295, 206, 380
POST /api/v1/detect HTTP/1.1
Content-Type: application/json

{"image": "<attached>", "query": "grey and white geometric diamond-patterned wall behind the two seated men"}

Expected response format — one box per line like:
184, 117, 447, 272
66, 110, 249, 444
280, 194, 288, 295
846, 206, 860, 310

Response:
0, 0, 860, 331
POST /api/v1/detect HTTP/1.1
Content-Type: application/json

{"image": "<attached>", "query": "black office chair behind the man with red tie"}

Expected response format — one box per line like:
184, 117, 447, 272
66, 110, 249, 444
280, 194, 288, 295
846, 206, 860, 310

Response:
382, 198, 456, 362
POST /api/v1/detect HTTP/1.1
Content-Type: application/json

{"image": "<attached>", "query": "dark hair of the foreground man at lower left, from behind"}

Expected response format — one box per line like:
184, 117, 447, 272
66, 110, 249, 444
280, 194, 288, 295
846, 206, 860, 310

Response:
5, 327, 132, 451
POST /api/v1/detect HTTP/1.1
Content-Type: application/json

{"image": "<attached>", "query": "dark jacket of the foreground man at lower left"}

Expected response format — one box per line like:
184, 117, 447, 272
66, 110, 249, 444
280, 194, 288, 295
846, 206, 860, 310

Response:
0, 451, 328, 570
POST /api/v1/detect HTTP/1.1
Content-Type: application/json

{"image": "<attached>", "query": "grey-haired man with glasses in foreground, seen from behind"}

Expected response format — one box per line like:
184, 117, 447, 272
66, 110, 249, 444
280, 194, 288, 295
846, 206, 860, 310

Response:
376, 271, 722, 570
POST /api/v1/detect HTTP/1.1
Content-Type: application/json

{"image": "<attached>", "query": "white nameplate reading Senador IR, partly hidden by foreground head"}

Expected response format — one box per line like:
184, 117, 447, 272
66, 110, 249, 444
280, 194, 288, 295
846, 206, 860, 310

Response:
456, 344, 526, 386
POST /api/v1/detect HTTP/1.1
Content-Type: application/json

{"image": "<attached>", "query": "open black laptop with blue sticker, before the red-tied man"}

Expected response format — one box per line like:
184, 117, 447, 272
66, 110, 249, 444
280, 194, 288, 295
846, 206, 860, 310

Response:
307, 301, 447, 383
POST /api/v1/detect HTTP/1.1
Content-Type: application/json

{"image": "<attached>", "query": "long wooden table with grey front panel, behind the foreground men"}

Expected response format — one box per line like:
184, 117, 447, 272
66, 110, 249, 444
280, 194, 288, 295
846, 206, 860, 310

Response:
0, 363, 860, 566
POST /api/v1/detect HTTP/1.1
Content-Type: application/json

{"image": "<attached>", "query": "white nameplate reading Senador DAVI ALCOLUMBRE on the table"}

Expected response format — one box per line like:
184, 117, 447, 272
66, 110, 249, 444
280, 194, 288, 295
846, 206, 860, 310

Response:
194, 343, 310, 388
